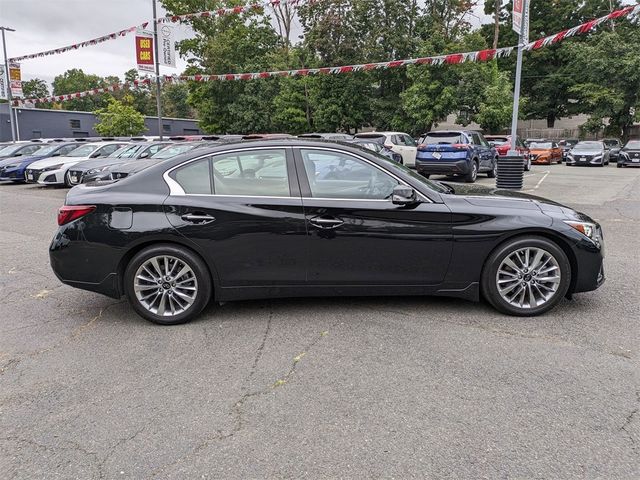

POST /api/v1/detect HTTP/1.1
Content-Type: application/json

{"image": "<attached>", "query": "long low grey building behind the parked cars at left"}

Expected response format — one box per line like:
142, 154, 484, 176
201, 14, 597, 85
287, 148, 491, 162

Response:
0, 103, 202, 142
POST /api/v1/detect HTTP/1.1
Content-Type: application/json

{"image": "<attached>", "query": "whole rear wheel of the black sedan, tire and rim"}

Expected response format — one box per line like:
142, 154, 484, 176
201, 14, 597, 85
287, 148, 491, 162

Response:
124, 244, 211, 325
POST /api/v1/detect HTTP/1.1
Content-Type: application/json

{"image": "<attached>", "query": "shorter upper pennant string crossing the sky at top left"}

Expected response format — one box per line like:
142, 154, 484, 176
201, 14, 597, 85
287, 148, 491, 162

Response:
9, 0, 308, 62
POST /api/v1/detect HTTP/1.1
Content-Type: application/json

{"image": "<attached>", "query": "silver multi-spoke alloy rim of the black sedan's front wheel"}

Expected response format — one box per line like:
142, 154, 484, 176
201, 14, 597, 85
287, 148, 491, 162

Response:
496, 247, 562, 309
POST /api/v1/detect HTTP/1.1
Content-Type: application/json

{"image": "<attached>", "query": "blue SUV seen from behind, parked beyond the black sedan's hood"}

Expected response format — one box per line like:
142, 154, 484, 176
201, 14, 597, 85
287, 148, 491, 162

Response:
416, 130, 498, 183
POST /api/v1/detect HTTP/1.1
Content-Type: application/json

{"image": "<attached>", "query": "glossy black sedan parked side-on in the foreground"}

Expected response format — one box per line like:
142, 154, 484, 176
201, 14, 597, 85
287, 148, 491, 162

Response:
50, 139, 604, 324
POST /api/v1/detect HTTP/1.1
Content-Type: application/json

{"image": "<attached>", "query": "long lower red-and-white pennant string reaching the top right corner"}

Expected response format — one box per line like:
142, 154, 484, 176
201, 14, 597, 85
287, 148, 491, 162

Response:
14, 5, 640, 105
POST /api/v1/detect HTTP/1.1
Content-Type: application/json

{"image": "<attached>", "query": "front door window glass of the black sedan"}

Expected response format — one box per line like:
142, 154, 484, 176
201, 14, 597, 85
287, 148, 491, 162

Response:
300, 149, 398, 200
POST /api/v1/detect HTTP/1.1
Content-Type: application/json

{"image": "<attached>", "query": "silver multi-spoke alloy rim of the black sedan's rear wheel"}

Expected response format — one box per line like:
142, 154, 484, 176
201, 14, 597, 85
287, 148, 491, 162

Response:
133, 255, 198, 317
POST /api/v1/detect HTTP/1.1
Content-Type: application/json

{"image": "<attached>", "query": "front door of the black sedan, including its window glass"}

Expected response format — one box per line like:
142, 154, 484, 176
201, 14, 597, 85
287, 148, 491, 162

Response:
296, 147, 452, 287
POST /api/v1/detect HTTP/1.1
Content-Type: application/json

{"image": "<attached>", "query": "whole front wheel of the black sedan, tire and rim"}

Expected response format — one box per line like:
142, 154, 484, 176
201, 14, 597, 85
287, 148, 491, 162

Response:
481, 237, 571, 317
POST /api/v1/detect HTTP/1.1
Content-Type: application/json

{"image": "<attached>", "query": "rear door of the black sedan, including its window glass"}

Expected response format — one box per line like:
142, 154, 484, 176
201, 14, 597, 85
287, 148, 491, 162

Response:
165, 147, 307, 288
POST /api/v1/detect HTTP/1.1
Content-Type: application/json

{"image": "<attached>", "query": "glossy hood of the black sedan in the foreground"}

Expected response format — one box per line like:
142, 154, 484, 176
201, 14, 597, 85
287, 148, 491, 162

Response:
442, 184, 580, 218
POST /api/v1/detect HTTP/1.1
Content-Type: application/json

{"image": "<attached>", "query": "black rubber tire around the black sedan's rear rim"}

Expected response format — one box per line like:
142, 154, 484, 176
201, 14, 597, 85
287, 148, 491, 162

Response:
123, 244, 212, 325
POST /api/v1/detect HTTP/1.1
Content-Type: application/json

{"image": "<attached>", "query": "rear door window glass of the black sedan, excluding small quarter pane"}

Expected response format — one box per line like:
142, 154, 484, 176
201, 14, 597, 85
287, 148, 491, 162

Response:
213, 149, 291, 197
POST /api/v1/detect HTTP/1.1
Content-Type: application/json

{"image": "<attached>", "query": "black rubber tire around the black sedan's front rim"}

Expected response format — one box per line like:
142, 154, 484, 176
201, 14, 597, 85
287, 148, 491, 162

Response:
481, 236, 571, 317
